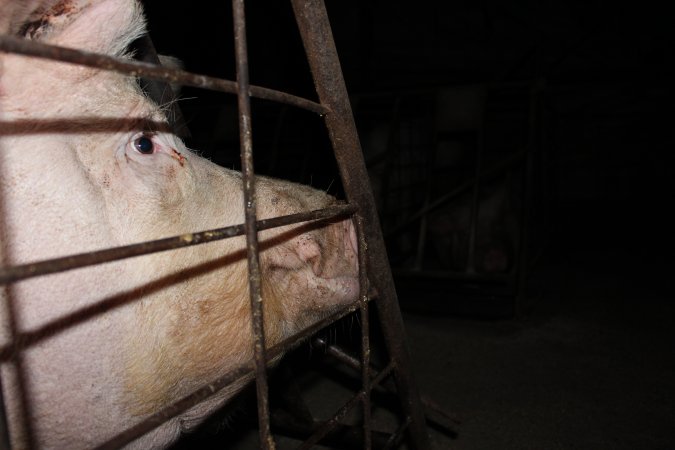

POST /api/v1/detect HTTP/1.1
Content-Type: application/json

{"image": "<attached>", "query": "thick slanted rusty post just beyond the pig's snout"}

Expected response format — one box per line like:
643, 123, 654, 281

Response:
291, 0, 430, 449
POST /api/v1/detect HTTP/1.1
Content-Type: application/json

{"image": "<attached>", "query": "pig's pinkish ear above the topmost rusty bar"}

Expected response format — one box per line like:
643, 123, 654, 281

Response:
0, 0, 145, 56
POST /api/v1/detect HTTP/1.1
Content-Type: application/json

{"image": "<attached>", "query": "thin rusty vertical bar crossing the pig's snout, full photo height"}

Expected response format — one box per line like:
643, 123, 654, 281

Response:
232, 0, 275, 450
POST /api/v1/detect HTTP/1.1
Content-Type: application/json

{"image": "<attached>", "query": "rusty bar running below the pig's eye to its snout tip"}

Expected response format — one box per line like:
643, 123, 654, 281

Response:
0, 205, 357, 285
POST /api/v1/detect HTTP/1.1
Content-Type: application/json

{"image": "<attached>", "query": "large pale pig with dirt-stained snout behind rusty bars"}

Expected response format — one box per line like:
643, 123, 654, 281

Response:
0, 0, 359, 449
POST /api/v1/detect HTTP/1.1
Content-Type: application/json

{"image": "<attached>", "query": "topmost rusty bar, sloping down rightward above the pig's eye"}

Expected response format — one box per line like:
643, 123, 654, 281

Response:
0, 35, 327, 114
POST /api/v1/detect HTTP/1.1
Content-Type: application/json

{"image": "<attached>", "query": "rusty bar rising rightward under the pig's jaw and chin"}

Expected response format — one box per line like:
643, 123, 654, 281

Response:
96, 301, 368, 450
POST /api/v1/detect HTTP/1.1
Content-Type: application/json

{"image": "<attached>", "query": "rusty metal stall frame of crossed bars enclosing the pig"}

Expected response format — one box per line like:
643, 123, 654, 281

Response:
0, 0, 430, 449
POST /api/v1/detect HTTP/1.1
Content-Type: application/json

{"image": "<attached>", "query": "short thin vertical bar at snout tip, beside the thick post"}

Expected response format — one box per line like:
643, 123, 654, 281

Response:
355, 216, 372, 450
